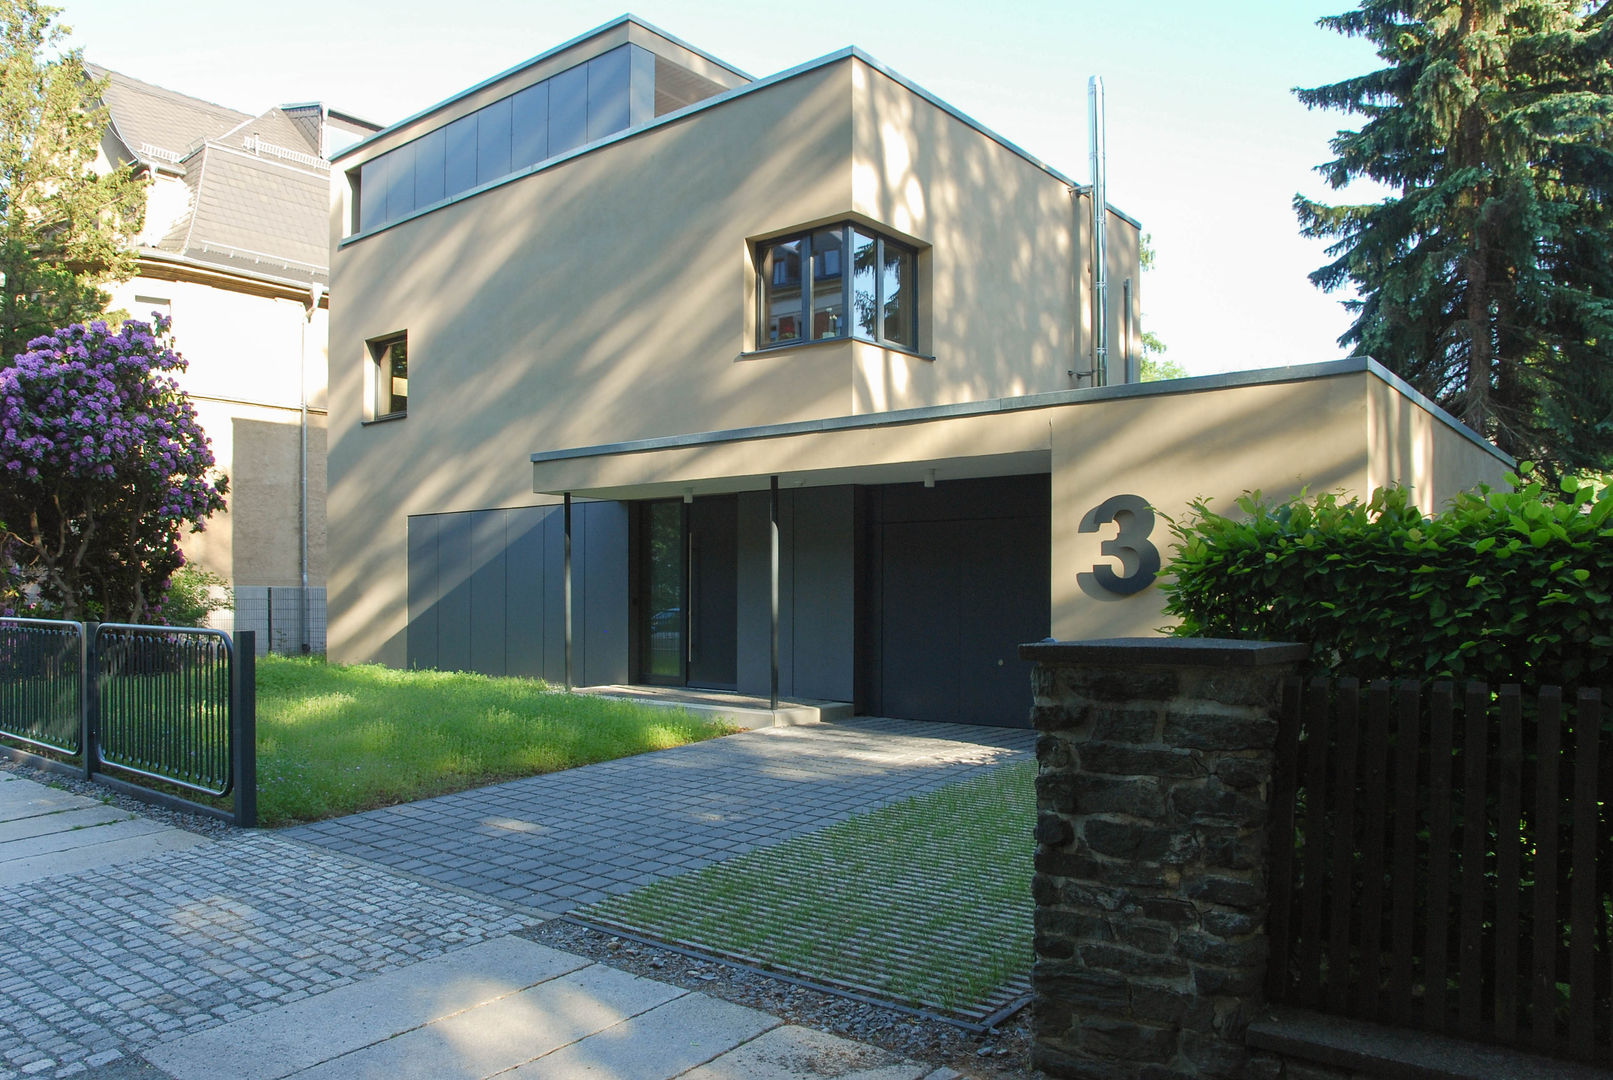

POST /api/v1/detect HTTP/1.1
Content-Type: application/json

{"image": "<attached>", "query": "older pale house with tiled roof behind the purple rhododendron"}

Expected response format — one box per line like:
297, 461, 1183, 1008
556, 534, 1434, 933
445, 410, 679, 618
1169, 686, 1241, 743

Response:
90, 68, 377, 651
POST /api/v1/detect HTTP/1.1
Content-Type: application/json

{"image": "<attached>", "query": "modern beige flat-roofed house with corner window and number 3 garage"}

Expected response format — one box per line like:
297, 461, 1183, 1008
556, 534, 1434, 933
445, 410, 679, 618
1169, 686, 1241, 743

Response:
327, 16, 1505, 724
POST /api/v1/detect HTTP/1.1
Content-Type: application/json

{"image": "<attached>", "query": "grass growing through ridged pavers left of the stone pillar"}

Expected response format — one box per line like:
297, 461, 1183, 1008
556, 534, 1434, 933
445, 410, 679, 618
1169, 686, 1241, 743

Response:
576, 762, 1036, 1012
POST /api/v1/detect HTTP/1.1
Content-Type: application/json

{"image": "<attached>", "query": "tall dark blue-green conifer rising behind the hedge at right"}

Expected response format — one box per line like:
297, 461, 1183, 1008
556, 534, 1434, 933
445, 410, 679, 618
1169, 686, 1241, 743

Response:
1294, 0, 1613, 471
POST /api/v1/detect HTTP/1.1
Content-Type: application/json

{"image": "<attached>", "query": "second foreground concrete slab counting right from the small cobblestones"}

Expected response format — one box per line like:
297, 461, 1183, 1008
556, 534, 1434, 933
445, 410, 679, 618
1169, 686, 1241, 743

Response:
297, 964, 687, 1080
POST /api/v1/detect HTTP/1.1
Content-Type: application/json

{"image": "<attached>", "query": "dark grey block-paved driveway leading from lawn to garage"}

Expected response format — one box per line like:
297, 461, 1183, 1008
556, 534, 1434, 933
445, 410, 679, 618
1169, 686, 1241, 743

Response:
287, 717, 1036, 912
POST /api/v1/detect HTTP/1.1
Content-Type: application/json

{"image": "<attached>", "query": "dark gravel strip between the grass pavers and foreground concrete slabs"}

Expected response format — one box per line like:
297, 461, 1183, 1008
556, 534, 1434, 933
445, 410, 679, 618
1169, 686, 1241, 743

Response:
518, 919, 1042, 1080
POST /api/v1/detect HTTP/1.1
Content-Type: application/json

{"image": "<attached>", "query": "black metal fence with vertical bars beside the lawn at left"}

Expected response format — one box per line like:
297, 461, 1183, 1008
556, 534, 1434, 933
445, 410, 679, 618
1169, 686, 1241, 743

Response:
0, 619, 256, 825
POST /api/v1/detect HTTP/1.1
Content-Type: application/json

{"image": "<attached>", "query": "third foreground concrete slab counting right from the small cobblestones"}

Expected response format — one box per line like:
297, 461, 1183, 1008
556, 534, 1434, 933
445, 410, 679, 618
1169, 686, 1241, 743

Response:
505, 993, 782, 1080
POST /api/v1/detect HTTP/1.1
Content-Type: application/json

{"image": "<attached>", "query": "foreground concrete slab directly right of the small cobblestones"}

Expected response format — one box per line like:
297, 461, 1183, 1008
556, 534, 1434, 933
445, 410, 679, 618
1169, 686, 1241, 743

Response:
145, 937, 589, 1080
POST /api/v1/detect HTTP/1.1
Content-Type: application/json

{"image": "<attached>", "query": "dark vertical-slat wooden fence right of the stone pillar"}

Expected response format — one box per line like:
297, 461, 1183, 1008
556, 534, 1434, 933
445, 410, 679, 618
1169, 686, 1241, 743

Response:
1266, 679, 1613, 1064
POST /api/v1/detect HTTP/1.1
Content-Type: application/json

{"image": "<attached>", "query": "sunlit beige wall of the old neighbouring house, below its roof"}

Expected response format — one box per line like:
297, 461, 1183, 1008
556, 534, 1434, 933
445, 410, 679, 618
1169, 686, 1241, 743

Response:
101, 277, 327, 585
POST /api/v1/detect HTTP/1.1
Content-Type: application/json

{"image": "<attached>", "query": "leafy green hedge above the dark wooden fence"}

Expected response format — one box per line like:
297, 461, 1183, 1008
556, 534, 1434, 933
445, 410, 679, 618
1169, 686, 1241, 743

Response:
1163, 463, 1613, 685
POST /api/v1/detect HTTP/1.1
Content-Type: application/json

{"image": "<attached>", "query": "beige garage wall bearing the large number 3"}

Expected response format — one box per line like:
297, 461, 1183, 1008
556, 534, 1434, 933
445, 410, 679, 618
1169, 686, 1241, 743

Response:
1052, 371, 1507, 640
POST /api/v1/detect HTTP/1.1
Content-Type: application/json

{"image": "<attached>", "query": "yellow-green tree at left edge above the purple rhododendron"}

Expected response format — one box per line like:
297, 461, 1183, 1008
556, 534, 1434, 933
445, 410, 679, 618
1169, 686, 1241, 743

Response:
0, 0, 145, 366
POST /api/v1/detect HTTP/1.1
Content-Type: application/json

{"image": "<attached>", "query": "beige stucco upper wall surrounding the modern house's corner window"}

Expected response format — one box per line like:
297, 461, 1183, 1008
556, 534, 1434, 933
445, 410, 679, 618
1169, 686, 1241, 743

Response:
329, 58, 1109, 664
